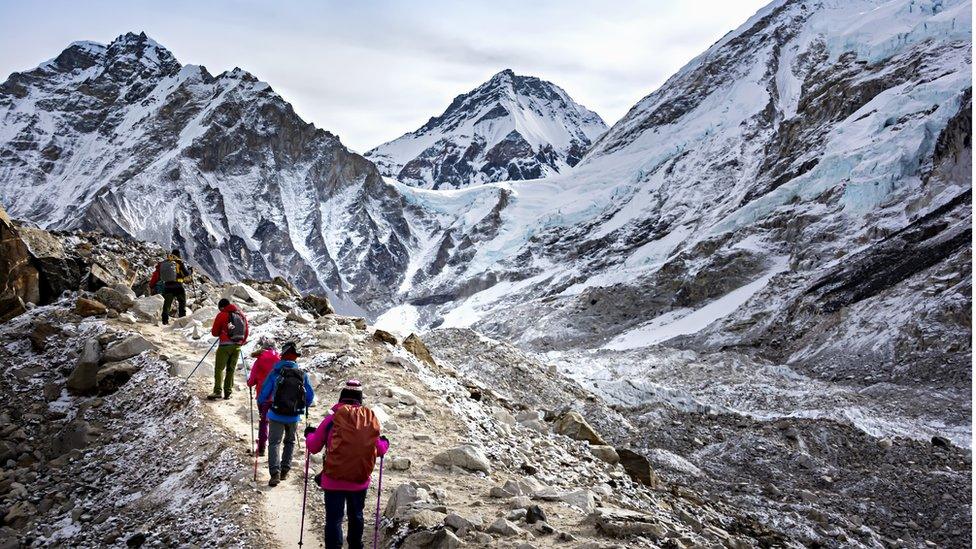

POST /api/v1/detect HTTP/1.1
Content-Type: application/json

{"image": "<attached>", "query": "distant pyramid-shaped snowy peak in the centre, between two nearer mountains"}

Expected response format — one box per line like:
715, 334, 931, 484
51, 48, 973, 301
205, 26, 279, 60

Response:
366, 70, 607, 189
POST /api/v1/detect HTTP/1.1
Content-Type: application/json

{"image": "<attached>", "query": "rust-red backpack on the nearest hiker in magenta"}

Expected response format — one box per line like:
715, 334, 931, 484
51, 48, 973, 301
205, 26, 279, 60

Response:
322, 404, 380, 483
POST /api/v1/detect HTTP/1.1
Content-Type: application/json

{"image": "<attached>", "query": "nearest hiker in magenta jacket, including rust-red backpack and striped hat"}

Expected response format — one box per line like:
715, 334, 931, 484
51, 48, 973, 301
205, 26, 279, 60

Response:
305, 379, 390, 549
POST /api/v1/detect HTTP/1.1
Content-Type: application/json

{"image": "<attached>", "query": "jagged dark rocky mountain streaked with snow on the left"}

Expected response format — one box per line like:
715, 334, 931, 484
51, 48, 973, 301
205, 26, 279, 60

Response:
0, 33, 410, 307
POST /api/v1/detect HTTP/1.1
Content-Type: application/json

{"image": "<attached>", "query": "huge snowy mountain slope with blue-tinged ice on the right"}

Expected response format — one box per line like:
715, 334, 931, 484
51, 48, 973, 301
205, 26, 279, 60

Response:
388, 0, 972, 382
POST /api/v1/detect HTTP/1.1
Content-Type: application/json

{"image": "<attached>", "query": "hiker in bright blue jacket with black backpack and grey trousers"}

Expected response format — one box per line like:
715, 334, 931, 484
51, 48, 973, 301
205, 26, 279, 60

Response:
258, 342, 315, 486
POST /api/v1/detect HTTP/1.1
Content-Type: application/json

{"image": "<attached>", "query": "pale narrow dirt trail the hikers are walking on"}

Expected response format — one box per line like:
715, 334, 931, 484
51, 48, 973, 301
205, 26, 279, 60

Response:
135, 324, 325, 549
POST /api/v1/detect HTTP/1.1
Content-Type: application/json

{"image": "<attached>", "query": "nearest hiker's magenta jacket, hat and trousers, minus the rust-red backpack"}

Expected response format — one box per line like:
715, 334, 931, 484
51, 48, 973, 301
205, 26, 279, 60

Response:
305, 379, 390, 549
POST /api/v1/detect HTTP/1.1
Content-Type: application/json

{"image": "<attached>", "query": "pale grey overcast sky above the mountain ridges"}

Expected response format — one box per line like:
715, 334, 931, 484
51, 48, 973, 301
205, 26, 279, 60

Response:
0, 0, 768, 152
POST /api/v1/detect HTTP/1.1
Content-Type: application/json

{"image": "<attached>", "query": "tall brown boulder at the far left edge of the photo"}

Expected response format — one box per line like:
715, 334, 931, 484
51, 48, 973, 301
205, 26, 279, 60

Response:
0, 206, 41, 322
